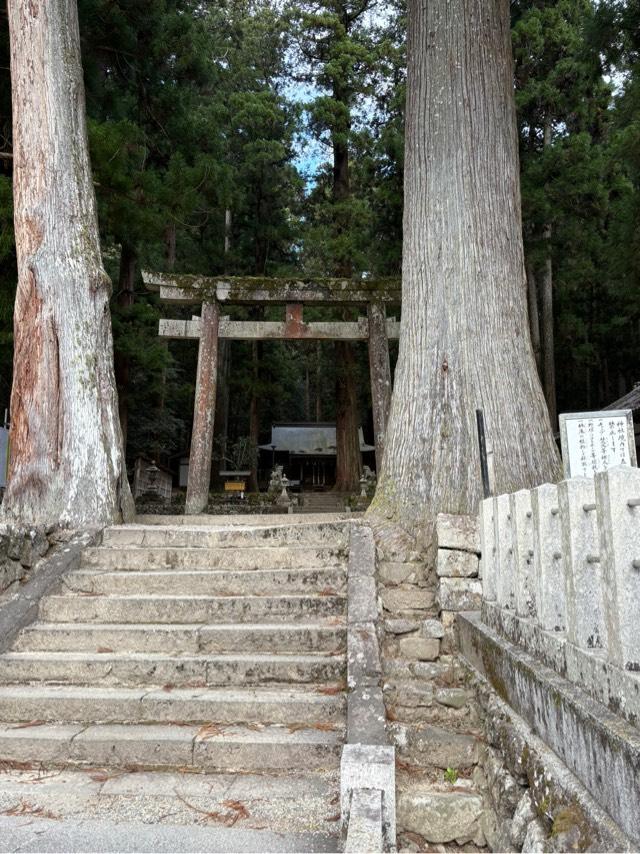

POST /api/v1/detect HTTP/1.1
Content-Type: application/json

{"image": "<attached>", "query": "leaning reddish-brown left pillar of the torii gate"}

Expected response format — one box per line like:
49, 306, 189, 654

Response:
184, 302, 220, 514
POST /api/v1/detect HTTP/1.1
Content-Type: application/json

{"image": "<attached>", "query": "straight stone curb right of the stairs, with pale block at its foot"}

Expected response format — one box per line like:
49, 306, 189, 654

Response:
340, 525, 396, 852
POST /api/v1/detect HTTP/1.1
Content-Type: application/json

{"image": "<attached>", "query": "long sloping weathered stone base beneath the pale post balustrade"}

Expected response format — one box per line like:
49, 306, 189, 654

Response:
458, 614, 640, 851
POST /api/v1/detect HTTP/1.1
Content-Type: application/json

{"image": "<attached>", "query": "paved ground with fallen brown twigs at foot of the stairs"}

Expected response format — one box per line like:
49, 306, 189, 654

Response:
0, 769, 340, 852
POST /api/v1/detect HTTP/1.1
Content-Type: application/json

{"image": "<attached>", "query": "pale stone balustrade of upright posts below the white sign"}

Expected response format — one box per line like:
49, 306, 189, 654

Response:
480, 466, 640, 724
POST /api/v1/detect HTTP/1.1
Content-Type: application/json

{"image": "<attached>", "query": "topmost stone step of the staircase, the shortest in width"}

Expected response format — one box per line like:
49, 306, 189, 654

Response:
102, 522, 349, 550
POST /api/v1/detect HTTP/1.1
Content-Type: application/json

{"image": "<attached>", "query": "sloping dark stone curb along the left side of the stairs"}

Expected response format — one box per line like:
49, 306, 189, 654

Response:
0, 529, 101, 652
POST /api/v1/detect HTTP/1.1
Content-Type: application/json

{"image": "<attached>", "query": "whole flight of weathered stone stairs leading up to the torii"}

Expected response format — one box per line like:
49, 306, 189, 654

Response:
0, 520, 349, 784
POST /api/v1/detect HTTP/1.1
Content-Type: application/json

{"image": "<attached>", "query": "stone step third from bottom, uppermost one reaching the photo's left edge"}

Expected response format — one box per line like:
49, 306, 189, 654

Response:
0, 651, 346, 693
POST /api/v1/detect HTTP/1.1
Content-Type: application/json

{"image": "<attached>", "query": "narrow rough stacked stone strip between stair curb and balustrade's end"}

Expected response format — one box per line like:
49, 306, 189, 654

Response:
376, 516, 496, 851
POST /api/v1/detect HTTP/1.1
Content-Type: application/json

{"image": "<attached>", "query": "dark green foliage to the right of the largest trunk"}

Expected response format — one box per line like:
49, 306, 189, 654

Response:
512, 0, 639, 410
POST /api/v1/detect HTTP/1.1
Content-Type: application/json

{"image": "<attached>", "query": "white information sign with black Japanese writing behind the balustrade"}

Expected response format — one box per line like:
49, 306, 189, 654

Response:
560, 409, 637, 478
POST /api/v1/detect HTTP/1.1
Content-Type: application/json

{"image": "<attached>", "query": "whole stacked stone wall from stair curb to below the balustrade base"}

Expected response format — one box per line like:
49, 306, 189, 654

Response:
376, 515, 628, 852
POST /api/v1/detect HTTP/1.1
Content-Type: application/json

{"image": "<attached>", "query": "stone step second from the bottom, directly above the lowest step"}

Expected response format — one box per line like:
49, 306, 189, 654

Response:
0, 684, 346, 726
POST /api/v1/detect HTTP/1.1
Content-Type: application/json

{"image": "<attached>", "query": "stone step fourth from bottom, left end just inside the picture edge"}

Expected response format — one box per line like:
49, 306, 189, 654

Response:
13, 618, 346, 655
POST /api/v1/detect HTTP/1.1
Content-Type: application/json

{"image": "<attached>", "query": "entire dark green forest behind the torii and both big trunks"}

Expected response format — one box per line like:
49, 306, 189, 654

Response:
0, 0, 640, 482
